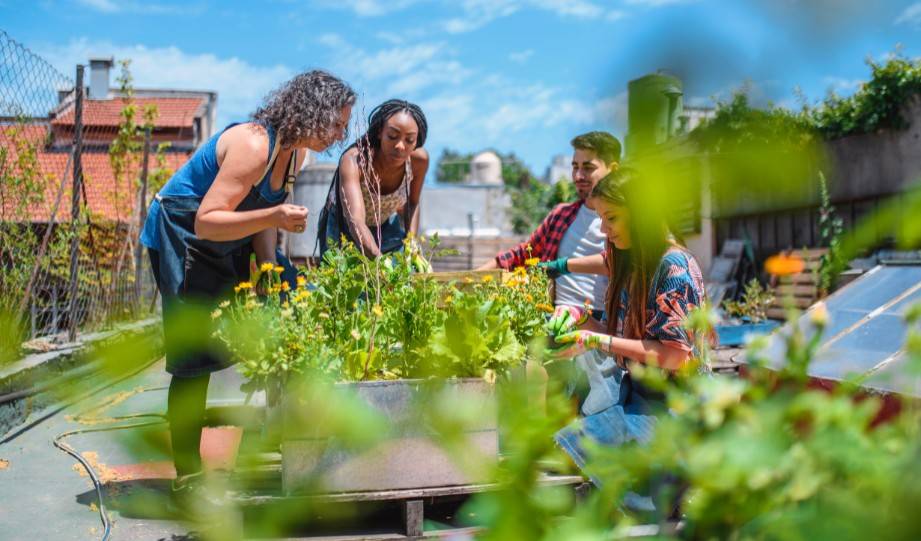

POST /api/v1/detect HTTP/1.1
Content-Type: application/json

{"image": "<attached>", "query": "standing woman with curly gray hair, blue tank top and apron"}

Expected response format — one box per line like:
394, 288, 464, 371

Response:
141, 70, 355, 516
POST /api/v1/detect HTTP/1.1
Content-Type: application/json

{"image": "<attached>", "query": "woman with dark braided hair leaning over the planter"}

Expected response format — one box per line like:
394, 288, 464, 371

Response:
317, 99, 429, 257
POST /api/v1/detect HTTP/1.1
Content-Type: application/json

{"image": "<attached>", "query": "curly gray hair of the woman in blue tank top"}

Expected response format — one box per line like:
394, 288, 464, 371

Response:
252, 70, 355, 147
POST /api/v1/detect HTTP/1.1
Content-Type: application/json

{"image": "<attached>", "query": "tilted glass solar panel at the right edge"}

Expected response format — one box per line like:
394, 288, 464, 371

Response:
748, 265, 921, 396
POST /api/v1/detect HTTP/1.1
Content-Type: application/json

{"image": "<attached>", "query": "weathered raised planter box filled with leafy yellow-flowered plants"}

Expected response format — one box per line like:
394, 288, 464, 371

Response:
213, 241, 549, 493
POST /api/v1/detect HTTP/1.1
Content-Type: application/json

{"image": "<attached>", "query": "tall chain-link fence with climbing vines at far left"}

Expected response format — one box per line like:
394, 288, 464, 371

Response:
0, 30, 162, 350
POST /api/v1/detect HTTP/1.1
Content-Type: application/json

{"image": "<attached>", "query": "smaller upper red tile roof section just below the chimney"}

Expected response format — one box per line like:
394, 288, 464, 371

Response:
51, 98, 204, 128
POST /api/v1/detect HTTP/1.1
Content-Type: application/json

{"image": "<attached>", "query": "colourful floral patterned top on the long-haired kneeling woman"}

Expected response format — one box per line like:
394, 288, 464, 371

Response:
616, 247, 706, 351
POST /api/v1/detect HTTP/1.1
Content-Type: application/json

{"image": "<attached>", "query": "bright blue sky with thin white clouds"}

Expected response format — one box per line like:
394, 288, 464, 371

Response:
0, 0, 921, 181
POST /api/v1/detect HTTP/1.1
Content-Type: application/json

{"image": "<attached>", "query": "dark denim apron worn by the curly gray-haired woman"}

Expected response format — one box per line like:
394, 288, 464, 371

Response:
156, 142, 296, 377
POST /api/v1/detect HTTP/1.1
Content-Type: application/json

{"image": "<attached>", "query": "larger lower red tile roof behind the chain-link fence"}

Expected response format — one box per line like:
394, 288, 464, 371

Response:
0, 124, 191, 222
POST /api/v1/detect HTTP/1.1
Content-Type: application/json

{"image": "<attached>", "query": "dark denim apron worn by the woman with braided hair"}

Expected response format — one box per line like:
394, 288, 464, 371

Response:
317, 150, 411, 262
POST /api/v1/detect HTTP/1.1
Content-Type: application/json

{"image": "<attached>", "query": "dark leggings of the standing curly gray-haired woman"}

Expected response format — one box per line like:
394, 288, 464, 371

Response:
147, 250, 211, 477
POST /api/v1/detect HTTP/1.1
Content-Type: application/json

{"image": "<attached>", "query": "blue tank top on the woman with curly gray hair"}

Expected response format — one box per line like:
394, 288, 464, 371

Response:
140, 122, 287, 250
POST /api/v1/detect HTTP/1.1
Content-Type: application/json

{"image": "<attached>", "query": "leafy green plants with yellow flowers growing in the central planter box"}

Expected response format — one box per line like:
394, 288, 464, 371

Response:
213, 239, 548, 385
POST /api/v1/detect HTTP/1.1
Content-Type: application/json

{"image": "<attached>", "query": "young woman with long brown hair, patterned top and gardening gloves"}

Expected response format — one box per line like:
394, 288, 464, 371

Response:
555, 168, 706, 506
